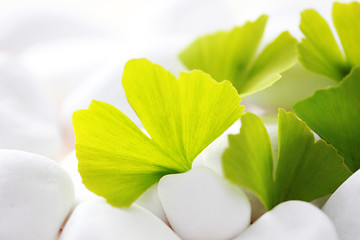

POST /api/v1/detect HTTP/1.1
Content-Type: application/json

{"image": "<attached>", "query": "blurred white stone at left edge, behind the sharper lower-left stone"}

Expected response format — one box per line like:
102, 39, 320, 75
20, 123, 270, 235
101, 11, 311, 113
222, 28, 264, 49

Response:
0, 55, 62, 157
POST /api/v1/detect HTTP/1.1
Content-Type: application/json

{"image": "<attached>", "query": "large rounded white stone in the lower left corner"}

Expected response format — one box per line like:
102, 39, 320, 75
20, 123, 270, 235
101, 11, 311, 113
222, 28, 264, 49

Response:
0, 149, 74, 240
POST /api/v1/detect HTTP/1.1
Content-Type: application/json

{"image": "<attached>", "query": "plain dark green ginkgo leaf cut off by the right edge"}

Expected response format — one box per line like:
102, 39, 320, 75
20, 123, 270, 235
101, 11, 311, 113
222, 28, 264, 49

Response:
293, 67, 360, 172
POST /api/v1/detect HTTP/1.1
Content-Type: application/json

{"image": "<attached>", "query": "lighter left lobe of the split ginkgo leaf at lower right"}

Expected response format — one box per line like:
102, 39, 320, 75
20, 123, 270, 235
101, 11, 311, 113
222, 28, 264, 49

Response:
223, 112, 274, 209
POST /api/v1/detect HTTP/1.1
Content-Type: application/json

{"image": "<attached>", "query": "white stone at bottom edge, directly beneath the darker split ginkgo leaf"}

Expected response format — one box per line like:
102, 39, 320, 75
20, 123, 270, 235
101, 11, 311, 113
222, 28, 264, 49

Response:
234, 201, 338, 240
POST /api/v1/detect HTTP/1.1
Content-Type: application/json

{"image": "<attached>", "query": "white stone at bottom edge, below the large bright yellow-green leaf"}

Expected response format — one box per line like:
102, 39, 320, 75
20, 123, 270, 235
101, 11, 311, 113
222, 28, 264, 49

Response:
60, 200, 180, 240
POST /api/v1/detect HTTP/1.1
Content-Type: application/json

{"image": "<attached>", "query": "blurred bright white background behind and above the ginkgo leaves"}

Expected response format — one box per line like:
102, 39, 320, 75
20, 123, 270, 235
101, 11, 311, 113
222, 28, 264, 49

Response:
0, 0, 356, 160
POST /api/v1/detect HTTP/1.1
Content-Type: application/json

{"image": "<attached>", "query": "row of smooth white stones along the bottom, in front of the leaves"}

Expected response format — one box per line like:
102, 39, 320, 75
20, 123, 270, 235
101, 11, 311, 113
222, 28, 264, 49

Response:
0, 150, 360, 240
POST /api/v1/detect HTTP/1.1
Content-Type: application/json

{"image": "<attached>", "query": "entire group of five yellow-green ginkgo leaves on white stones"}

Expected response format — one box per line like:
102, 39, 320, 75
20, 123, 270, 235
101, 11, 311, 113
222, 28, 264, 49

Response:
73, 3, 360, 209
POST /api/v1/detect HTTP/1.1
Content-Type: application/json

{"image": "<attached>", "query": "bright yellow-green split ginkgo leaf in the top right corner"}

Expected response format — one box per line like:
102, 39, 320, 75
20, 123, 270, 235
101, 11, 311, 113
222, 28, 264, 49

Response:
299, 2, 360, 82
